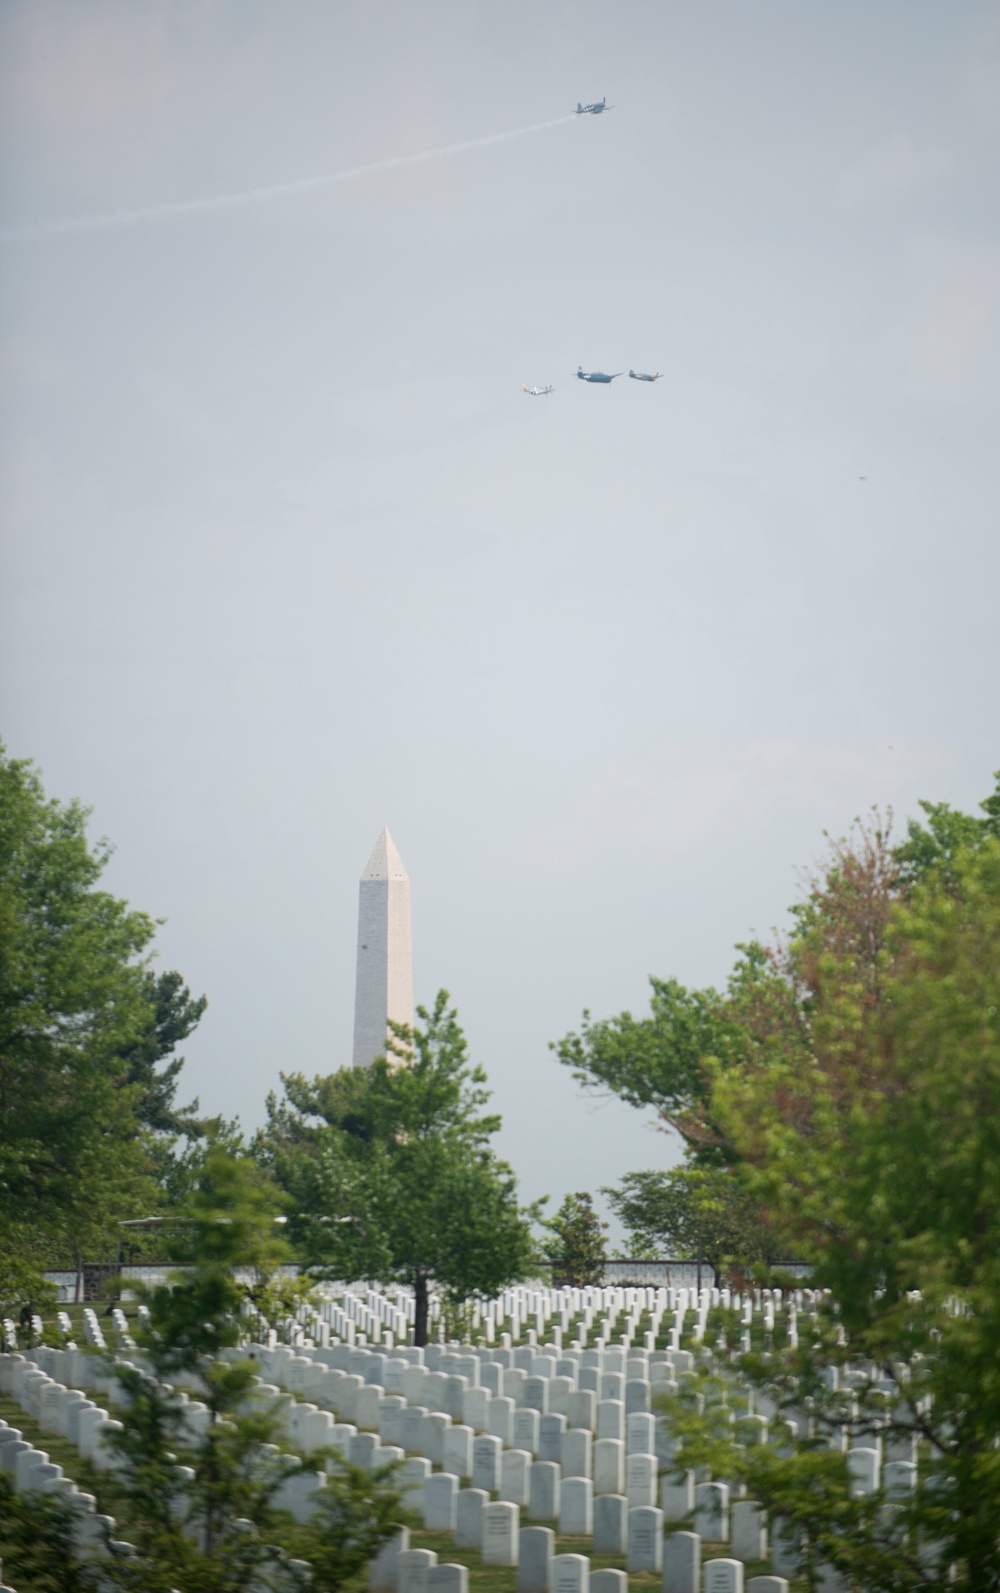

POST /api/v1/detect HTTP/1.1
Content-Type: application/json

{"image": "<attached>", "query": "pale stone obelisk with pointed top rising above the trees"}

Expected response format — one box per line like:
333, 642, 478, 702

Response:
354, 830, 412, 1067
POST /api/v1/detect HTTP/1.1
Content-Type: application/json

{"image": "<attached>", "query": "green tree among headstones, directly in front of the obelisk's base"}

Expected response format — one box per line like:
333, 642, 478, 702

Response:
258, 991, 533, 1344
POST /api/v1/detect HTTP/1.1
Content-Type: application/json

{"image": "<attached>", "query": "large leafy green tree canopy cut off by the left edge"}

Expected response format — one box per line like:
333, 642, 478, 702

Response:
0, 746, 204, 1274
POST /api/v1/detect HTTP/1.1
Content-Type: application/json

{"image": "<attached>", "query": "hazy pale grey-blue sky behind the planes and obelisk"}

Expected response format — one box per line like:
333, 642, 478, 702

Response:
0, 0, 1000, 1229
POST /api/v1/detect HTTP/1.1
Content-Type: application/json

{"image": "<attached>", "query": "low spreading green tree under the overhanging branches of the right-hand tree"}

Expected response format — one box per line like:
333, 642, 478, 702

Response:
604, 1164, 779, 1286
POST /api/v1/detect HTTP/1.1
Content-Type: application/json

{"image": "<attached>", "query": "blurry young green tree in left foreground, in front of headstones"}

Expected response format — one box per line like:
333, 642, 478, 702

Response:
108, 1144, 404, 1593
